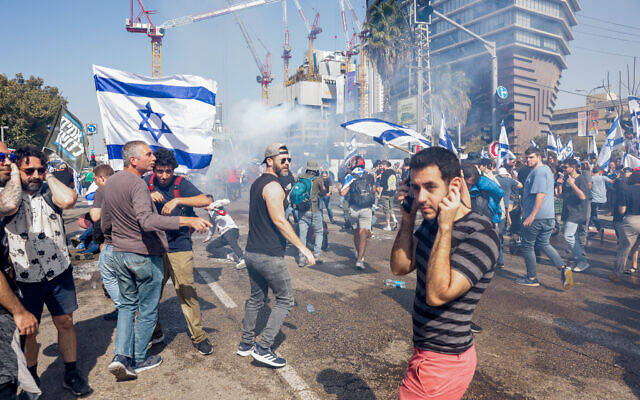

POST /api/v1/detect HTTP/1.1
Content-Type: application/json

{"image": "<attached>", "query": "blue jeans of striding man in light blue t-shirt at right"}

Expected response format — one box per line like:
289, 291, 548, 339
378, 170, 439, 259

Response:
521, 218, 564, 279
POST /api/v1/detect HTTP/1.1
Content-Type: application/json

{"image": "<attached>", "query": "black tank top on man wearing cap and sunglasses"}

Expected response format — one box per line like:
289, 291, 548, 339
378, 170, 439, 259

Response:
247, 174, 287, 257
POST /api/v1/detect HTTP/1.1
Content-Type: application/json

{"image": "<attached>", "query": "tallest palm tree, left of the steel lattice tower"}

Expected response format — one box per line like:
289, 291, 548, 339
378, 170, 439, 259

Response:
365, 1, 412, 111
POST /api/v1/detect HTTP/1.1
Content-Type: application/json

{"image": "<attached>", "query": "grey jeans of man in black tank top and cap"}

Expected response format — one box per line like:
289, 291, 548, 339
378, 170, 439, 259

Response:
242, 252, 294, 348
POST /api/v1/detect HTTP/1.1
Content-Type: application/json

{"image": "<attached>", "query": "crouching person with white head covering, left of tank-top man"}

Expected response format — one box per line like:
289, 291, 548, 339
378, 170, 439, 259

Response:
202, 195, 247, 269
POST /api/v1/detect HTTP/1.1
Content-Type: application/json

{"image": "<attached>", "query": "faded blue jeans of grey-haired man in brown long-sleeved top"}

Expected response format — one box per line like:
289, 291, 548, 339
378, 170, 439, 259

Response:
113, 251, 164, 362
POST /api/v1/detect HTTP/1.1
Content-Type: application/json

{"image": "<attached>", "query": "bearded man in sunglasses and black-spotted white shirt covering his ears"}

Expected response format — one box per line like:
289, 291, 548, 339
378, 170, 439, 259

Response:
5, 145, 91, 396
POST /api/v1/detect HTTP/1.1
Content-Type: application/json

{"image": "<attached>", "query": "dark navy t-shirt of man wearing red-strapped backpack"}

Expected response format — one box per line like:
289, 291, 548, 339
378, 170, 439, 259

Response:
143, 175, 202, 253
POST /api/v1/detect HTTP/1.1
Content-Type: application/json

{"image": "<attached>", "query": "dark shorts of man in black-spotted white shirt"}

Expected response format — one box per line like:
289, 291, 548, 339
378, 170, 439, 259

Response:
18, 266, 78, 323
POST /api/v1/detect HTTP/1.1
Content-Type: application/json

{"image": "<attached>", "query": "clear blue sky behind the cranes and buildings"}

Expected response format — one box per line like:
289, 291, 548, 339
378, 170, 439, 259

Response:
0, 0, 640, 150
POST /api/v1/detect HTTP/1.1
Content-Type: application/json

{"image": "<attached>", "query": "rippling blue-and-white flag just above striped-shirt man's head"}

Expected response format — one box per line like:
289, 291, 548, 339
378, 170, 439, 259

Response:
340, 118, 431, 151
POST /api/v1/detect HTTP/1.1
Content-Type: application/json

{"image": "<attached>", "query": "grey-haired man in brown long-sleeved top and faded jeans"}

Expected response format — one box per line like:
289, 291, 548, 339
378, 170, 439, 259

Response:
101, 140, 211, 380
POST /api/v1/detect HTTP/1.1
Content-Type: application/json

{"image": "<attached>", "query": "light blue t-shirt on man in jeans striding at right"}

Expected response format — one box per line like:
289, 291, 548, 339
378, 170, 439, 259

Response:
522, 165, 555, 220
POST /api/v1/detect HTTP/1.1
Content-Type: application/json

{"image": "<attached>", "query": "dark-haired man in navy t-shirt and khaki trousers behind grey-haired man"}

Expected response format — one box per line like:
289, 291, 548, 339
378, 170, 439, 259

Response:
144, 149, 213, 355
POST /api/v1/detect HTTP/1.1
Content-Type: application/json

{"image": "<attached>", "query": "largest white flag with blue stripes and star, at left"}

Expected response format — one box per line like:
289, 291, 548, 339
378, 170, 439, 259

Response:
93, 65, 217, 173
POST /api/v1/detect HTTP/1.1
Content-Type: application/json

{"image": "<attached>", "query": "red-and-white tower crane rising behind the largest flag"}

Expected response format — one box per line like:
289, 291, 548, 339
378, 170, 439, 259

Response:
125, 0, 280, 77
